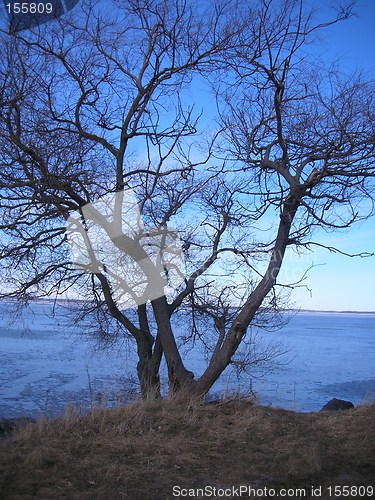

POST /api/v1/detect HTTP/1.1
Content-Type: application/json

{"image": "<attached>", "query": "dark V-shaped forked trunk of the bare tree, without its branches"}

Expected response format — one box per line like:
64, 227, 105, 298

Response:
138, 187, 303, 398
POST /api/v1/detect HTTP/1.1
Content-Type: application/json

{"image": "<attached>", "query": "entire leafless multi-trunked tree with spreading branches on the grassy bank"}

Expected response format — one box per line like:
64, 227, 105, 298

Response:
0, 0, 374, 396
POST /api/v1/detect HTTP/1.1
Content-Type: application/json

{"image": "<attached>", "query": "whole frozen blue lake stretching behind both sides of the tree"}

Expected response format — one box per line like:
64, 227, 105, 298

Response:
0, 302, 375, 417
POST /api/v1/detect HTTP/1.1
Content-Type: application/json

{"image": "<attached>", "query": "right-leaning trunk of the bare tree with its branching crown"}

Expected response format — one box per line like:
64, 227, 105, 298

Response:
191, 1, 375, 390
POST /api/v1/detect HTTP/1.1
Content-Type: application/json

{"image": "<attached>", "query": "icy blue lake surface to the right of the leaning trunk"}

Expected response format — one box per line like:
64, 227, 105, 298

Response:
241, 312, 375, 411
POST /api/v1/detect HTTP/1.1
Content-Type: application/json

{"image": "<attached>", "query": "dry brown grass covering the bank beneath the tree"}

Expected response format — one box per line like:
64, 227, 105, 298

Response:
0, 400, 375, 500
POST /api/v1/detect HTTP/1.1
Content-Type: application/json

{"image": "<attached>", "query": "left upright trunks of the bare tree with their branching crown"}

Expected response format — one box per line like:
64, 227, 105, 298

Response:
0, 0, 244, 394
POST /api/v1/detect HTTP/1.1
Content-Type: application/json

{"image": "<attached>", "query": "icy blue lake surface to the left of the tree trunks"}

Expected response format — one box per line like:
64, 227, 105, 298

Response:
0, 304, 135, 417
